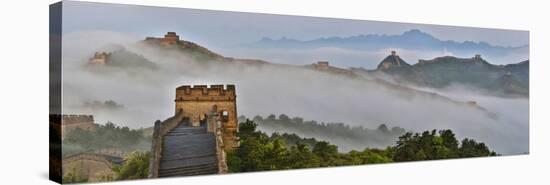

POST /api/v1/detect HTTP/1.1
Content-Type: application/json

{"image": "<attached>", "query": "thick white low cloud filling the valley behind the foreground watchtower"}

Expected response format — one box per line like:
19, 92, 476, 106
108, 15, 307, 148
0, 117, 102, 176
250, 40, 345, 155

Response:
63, 32, 529, 154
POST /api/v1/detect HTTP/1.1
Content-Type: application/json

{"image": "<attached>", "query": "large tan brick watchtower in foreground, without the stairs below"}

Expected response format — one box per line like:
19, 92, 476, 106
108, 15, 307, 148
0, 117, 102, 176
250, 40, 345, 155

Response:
175, 85, 238, 148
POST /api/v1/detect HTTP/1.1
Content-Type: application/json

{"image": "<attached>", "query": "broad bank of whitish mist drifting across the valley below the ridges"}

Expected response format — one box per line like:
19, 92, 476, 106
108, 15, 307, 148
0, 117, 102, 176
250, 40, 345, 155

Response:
62, 31, 529, 154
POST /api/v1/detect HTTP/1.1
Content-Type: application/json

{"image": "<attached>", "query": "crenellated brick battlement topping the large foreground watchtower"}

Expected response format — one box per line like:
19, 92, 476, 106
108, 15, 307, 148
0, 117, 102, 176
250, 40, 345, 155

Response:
175, 85, 236, 102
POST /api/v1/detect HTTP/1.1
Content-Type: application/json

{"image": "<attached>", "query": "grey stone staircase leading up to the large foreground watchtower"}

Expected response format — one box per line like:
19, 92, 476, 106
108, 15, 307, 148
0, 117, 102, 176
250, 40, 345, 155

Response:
158, 122, 219, 177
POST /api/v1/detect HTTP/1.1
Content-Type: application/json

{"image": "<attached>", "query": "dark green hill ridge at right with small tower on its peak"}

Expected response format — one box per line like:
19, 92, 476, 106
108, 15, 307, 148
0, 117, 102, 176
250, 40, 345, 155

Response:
367, 52, 529, 96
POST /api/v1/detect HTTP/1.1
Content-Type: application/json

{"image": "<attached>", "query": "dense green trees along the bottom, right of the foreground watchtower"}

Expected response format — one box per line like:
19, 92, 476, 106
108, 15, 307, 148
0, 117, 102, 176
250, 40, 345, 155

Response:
227, 118, 496, 172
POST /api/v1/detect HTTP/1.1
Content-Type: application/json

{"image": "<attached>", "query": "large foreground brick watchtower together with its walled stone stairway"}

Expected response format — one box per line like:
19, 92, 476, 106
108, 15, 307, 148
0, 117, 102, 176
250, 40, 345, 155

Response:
149, 85, 239, 178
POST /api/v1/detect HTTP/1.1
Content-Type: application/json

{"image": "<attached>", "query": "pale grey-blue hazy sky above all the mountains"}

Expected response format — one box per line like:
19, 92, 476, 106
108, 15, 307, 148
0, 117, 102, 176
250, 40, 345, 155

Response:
63, 1, 529, 48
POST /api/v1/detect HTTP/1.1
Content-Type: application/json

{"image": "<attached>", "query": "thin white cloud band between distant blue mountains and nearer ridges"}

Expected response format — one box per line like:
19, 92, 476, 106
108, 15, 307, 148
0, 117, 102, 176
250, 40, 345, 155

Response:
219, 47, 528, 69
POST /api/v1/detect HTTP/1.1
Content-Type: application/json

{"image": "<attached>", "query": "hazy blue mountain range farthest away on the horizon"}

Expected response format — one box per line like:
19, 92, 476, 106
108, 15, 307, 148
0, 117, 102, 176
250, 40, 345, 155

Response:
248, 29, 529, 56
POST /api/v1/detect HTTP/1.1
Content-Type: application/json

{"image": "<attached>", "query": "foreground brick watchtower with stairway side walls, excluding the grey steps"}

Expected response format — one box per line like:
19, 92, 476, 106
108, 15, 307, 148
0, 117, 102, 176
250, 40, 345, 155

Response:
149, 85, 239, 178
